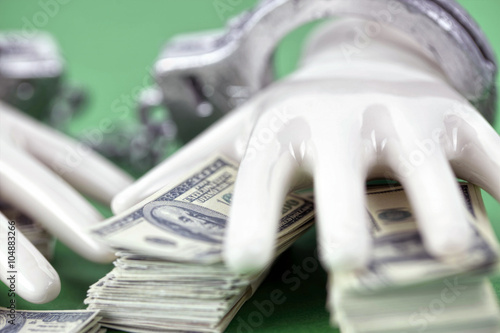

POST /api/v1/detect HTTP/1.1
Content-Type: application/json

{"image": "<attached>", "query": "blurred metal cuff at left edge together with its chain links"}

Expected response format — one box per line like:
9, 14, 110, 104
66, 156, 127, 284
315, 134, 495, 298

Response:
0, 31, 175, 174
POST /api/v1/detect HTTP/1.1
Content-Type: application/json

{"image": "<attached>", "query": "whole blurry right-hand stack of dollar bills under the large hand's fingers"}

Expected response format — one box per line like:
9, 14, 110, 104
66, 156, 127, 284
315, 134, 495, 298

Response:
328, 183, 500, 333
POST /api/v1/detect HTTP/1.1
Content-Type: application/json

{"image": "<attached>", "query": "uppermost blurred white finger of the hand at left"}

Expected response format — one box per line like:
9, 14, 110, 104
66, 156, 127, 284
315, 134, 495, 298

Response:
0, 102, 132, 204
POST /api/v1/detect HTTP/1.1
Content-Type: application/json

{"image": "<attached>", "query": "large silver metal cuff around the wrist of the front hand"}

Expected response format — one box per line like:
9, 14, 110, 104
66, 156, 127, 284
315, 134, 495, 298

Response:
139, 0, 497, 141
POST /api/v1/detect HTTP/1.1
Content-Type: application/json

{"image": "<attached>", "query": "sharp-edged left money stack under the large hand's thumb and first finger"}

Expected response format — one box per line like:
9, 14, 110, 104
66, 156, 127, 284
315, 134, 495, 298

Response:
85, 156, 314, 332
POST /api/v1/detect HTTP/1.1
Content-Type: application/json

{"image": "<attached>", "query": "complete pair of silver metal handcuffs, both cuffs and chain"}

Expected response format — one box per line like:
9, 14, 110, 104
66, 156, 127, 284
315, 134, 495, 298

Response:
0, 0, 497, 172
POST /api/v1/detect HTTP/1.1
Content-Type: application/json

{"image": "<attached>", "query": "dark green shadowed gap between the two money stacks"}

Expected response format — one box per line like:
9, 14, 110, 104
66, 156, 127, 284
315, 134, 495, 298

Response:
226, 228, 338, 333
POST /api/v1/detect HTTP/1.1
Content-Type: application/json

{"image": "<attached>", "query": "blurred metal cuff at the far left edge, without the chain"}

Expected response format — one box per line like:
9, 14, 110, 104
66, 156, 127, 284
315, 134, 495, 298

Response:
0, 31, 86, 129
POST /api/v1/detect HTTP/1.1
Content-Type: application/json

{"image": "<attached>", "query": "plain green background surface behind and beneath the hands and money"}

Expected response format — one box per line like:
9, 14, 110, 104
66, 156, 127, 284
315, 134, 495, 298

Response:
0, 0, 500, 332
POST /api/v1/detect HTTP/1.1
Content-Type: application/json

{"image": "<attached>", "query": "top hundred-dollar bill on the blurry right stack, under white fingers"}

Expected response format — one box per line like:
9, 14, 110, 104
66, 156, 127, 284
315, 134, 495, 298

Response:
335, 183, 499, 292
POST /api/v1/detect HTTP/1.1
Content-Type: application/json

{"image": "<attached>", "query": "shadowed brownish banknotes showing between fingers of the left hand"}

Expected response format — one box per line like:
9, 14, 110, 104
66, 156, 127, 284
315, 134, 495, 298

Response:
0, 200, 55, 259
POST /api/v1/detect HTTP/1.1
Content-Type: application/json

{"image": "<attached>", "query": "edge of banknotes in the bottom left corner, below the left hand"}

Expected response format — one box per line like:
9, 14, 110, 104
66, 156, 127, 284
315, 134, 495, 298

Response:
0, 307, 106, 333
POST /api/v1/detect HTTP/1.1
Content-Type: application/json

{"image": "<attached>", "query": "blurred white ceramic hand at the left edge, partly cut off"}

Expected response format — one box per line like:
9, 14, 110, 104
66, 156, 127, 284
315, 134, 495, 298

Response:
0, 103, 132, 303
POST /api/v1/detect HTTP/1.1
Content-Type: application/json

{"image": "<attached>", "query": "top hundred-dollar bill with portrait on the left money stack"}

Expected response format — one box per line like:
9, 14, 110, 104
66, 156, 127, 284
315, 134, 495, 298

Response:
91, 156, 314, 263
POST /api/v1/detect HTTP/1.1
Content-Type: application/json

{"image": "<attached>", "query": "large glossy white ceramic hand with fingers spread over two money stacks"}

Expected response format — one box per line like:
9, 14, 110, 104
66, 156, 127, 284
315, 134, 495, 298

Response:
112, 20, 500, 271
